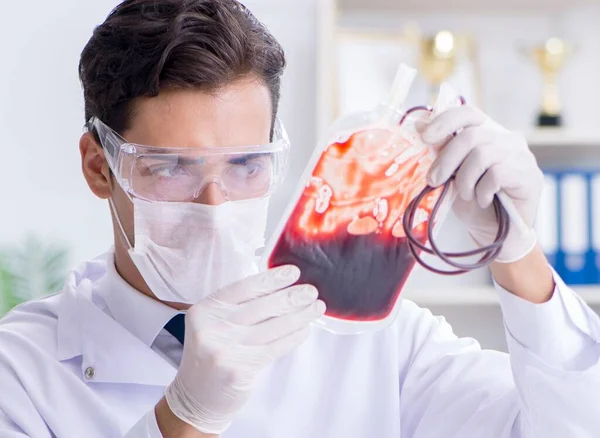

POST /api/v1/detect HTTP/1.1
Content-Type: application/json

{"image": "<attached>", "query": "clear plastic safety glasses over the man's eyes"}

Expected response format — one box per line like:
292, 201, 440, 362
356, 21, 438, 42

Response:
88, 117, 290, 202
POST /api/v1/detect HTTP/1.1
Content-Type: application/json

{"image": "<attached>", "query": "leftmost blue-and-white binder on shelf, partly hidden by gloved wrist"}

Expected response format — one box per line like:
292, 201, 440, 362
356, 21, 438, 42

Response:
534, 171, 559, 269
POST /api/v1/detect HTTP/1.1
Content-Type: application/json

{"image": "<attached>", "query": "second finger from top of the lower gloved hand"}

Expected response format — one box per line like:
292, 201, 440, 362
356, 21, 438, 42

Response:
230, 284, 319, 326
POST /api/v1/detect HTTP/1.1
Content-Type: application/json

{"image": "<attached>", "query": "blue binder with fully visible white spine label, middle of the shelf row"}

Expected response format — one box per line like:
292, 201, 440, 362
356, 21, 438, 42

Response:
556, 171, 595, 284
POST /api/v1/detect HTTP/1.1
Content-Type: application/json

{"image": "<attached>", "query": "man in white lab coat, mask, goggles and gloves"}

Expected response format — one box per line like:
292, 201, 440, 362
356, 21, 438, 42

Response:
0, 0, 600, 438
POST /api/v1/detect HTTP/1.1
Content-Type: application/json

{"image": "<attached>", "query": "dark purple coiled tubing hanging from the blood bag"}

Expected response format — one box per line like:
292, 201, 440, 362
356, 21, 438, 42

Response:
399, 97, 510, 275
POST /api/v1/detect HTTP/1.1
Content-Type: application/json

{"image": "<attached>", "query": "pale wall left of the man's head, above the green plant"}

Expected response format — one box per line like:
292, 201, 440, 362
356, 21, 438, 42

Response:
0, 0, 121, 266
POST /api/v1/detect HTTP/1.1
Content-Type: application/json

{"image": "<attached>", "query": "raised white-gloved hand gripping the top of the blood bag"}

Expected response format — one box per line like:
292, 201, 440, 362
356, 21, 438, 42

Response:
420, 105, 544, 263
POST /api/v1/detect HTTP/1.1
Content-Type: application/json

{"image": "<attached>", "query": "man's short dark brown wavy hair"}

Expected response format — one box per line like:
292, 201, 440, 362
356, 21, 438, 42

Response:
79, 0, 285, 133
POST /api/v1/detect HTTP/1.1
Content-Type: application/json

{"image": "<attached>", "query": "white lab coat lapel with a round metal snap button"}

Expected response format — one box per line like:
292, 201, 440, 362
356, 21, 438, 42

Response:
57, 253, 177, 386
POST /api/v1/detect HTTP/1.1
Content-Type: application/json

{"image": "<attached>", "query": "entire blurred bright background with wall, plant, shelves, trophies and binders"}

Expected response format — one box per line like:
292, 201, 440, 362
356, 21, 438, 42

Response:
0, 0, 600, 350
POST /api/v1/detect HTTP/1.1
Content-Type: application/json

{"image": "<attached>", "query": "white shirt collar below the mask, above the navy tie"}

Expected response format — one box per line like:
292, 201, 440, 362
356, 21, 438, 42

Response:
99, 253, 182, 347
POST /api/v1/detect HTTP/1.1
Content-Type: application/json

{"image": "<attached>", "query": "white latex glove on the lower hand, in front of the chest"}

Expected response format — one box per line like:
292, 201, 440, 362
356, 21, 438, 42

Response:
165, 266, 325, 435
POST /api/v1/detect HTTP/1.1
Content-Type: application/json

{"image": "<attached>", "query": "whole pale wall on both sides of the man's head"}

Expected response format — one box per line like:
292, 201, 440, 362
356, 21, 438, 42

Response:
0, 0, 316, 263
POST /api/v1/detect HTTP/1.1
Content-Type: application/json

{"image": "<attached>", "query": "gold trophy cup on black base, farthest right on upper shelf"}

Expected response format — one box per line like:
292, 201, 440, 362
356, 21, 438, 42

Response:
529, 38, 571, 127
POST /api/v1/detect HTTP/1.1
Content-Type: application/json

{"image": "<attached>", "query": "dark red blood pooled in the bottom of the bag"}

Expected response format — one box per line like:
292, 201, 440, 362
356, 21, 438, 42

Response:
269, 230, 422, 321
